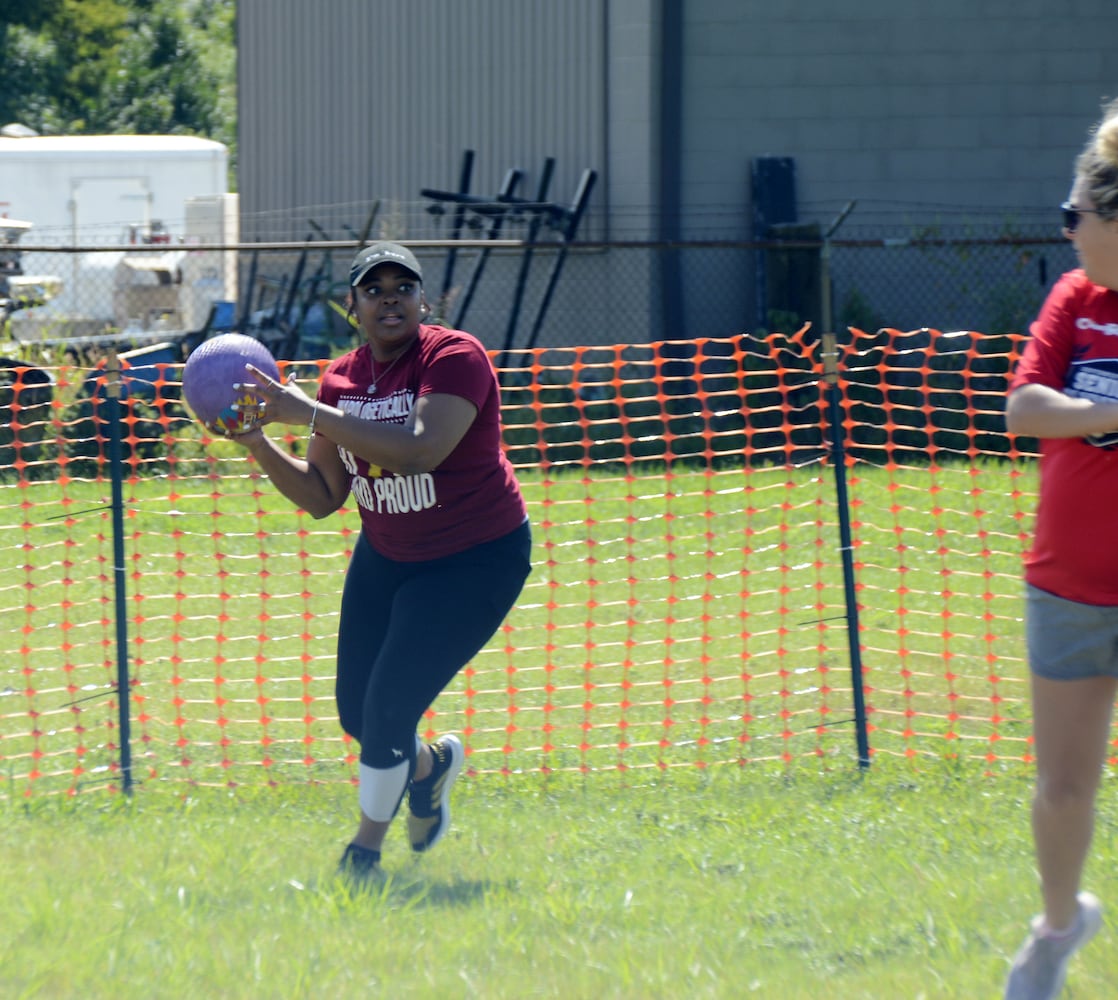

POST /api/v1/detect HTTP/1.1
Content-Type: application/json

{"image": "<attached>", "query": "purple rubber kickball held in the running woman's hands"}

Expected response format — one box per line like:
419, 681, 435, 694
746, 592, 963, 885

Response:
182, 333, 280, 434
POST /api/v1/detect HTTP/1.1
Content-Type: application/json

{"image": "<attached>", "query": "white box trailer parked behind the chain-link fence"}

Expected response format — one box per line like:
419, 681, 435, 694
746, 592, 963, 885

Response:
0, 135, 236, 336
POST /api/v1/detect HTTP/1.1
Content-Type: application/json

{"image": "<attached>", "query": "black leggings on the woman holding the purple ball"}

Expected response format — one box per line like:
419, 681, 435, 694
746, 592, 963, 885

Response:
334, 521, 532, 767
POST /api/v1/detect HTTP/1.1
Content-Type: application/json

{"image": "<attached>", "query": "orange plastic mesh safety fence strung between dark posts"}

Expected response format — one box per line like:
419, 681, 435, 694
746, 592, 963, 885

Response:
0, 330, 1035, 796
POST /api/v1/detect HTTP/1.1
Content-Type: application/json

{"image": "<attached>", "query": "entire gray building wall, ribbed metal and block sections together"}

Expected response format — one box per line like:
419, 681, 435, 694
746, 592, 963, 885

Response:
238, 0, 1118, 347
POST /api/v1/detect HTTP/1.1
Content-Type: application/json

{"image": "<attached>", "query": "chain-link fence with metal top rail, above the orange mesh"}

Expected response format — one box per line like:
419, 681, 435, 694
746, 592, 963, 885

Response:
0, 225, 1074, 364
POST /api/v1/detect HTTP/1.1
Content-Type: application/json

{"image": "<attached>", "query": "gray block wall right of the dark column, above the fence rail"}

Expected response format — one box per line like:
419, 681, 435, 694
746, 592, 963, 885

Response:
684, 0, 1118, 236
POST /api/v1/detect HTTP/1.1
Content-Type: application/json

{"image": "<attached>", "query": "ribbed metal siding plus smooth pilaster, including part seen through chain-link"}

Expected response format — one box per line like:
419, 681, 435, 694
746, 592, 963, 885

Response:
238, 0, 639, 348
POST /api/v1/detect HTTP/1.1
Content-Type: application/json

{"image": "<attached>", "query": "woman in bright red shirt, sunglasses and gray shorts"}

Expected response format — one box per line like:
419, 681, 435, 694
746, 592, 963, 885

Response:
1005, 102, 1118, 1000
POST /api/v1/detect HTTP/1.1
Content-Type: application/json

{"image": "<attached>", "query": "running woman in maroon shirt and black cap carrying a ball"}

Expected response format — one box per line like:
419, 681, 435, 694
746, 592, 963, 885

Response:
235, 243, 531, 878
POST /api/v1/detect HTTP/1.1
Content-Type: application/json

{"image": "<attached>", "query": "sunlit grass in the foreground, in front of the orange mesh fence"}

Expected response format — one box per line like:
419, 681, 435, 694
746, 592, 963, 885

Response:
0, 761, 1118, 1000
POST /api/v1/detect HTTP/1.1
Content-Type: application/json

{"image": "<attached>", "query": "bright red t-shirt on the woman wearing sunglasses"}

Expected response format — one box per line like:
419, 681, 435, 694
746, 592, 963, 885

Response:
1010, 270, 1118, 605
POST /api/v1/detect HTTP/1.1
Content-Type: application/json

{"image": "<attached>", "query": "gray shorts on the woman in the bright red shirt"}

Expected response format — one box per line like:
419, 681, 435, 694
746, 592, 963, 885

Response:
1025, 584, 1118, 680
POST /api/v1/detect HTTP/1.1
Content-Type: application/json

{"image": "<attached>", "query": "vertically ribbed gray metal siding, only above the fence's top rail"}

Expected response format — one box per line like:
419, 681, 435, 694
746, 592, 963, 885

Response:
238, 0, 606, 239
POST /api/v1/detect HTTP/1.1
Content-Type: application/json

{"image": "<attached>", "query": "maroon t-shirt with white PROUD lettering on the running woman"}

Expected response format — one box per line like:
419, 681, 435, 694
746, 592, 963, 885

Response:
319, 326, 527, 563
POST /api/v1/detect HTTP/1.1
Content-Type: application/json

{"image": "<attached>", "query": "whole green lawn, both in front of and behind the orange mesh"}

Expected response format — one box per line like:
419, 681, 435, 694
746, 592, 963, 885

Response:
0, 462, 1118, 1000
